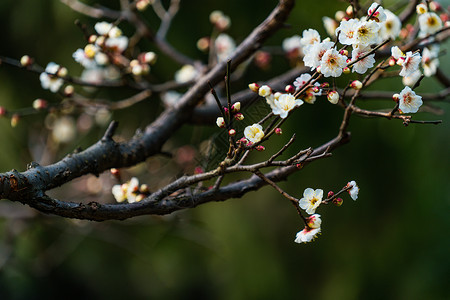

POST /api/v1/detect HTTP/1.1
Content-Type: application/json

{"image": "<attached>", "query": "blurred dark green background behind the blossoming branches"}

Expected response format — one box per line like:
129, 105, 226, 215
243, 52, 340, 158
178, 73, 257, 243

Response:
0, 0, 450, 299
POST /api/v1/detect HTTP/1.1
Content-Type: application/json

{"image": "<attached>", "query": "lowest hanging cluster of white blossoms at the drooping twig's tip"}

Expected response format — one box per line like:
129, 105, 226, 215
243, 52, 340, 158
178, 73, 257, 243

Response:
295, 180, 359, 244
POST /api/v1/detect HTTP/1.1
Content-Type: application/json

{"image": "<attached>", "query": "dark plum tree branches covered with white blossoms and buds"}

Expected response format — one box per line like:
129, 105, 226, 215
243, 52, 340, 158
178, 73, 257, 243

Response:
0, 0, 450, 243
